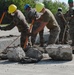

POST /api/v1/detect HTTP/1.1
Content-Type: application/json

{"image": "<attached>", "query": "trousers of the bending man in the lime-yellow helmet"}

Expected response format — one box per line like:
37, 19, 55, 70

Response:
48, 27, 60, 44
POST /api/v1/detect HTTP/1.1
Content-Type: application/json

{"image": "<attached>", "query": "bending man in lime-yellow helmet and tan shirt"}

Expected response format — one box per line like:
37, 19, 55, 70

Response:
28, 3, 60, 44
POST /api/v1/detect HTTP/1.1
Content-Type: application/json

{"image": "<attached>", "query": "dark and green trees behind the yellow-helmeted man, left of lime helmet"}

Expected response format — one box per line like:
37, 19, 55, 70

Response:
0, 0, 35, 24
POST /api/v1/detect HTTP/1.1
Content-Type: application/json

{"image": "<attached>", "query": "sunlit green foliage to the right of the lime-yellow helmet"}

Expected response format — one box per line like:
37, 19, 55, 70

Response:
43, 0, 68, 14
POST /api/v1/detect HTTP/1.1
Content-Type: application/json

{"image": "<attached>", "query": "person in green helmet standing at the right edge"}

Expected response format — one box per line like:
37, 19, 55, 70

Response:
65, 0, 74, 53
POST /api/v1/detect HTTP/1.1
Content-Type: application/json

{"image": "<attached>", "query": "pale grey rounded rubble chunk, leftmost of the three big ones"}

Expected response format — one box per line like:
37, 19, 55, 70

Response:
7, 47, 25, 61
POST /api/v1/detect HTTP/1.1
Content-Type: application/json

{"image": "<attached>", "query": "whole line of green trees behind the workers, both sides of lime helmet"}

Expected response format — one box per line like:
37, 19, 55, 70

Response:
0, 0, 68, 23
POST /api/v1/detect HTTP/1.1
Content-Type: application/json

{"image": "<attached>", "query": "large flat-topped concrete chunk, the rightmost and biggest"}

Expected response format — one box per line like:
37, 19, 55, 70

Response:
46, 45, 72, 60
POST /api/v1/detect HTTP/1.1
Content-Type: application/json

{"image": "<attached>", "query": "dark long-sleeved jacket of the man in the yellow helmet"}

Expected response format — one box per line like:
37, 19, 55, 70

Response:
1, 10, 29, 32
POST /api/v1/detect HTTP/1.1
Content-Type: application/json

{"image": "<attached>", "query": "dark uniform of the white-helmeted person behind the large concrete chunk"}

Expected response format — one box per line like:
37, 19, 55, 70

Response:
55, 11, 69, 44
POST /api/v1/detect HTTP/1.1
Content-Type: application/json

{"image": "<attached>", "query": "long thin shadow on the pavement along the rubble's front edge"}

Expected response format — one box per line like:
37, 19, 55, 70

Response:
0, 59, 70, 65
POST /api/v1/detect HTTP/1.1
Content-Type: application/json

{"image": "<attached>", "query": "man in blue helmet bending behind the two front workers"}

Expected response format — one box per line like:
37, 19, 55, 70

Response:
24, 4, 44, 46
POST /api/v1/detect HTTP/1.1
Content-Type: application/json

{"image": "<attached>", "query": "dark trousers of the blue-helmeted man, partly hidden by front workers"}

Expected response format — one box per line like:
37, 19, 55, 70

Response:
31, 22, 44, 45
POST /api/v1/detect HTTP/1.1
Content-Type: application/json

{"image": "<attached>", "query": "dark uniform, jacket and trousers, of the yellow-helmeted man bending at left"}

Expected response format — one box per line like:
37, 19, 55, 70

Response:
1, 10, 29, 48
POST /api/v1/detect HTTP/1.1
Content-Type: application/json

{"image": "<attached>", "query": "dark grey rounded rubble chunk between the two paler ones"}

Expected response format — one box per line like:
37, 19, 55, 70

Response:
25, 47, 43, 60
